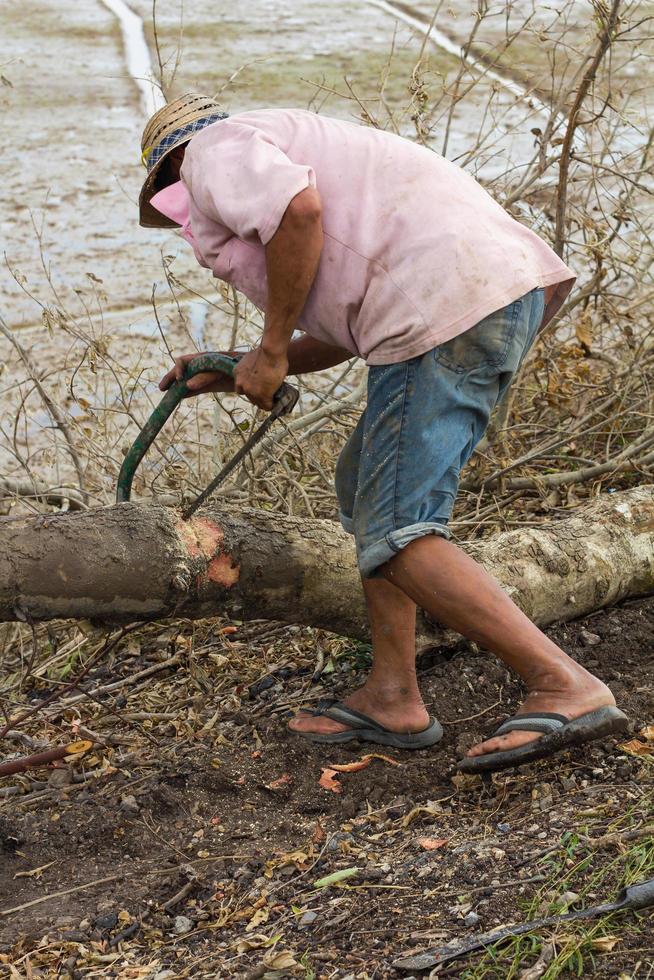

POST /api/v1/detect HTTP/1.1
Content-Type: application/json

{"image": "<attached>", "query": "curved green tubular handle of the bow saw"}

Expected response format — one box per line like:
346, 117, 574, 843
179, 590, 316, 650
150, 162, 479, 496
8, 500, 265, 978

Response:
116, 352, 297, 504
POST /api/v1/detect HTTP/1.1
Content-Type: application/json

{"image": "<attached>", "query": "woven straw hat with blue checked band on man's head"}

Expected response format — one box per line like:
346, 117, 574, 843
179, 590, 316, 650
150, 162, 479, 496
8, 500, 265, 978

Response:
139, 92, 227, 228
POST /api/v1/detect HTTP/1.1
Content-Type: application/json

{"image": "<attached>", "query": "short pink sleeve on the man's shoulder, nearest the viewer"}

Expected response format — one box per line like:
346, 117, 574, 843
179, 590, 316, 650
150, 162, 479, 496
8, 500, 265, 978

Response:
181, 120, 316, 245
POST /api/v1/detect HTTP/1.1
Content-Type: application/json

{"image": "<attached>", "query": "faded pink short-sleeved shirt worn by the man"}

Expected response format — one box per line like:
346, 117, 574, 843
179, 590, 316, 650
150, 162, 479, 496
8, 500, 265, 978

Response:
152, 109, 575, 364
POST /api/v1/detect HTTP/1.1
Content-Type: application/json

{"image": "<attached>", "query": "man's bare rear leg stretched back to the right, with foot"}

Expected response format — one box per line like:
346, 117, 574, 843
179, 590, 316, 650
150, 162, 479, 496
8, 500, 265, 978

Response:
382, 535, 615, 756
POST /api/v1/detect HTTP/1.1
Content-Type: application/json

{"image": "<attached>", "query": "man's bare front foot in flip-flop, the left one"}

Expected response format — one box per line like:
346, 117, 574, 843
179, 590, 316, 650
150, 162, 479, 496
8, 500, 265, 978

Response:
288, 682, 429, 735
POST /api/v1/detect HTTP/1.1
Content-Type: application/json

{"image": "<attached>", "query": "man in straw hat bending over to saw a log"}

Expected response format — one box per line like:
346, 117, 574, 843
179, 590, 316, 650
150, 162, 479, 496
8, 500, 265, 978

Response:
140, 95, 626, 772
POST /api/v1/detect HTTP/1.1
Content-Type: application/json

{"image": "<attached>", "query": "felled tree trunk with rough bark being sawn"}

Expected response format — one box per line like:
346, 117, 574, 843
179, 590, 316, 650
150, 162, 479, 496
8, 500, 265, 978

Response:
0, 486, 654, 645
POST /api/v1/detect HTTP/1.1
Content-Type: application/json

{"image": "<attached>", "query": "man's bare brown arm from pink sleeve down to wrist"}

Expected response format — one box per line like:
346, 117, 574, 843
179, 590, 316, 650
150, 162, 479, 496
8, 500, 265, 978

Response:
261, 188, 323, 358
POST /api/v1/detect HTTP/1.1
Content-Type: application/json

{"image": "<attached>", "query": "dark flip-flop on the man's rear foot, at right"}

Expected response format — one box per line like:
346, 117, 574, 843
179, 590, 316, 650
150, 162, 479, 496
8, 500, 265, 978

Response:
457, 704, 629, 773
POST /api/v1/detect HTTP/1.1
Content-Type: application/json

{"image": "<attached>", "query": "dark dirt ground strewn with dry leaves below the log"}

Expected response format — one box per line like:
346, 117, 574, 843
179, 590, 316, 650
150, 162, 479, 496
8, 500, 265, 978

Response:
0, 599, 654, 980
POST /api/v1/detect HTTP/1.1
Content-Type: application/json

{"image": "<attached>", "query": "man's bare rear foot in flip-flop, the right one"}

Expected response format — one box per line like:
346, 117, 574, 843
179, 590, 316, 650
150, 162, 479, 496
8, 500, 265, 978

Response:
467, 664, 615, 757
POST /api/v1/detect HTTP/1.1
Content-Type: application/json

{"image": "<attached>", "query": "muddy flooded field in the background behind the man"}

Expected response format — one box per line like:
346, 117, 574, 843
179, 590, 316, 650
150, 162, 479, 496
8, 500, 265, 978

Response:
0, 0, 651, 499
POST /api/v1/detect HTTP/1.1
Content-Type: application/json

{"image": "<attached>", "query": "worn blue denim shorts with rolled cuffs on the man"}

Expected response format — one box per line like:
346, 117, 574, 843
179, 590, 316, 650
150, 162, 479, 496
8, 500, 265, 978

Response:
336, 289, 545, 578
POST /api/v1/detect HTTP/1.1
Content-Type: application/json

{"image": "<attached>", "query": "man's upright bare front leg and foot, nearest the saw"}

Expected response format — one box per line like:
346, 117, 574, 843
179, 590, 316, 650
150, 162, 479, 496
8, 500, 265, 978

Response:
289, 579, 429, 734
